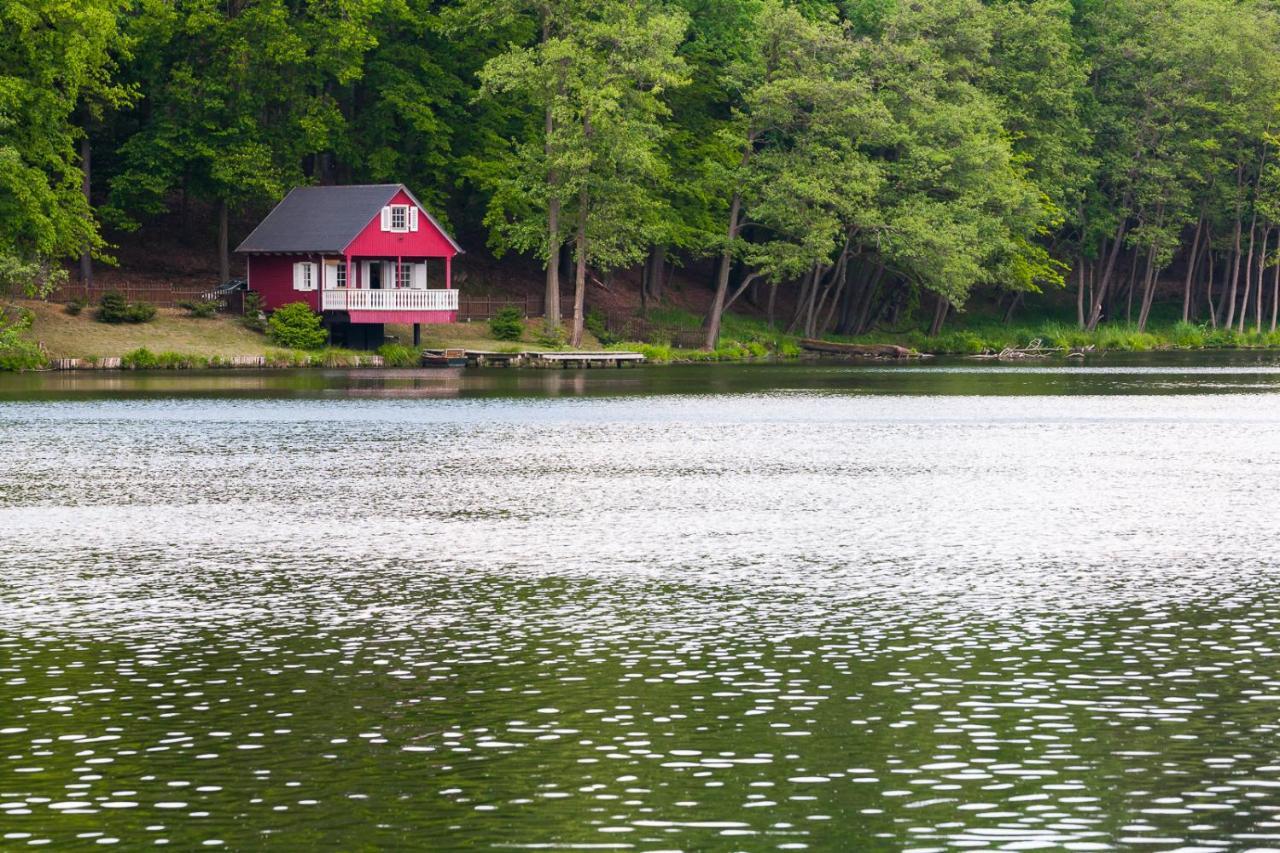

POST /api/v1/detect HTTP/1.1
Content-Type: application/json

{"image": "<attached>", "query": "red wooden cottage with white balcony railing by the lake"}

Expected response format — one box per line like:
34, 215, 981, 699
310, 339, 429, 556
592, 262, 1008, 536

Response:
236, 183, 462, 347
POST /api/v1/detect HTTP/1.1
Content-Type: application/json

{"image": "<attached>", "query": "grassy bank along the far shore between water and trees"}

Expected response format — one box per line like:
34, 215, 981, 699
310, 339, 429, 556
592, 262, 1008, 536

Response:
19, 294, 1280, 369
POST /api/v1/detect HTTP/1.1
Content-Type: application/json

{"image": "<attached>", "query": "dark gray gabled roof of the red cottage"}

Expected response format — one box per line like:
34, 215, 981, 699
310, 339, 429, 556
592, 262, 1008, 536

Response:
236, 183, 462, 254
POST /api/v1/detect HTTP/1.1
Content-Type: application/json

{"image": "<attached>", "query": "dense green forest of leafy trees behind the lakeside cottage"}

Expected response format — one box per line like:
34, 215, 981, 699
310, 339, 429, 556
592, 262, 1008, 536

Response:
0, 0, 1280, 347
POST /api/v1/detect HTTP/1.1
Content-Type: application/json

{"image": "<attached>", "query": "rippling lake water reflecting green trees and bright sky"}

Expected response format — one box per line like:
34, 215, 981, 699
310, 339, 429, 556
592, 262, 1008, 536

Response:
0, 356, 1280, 850
